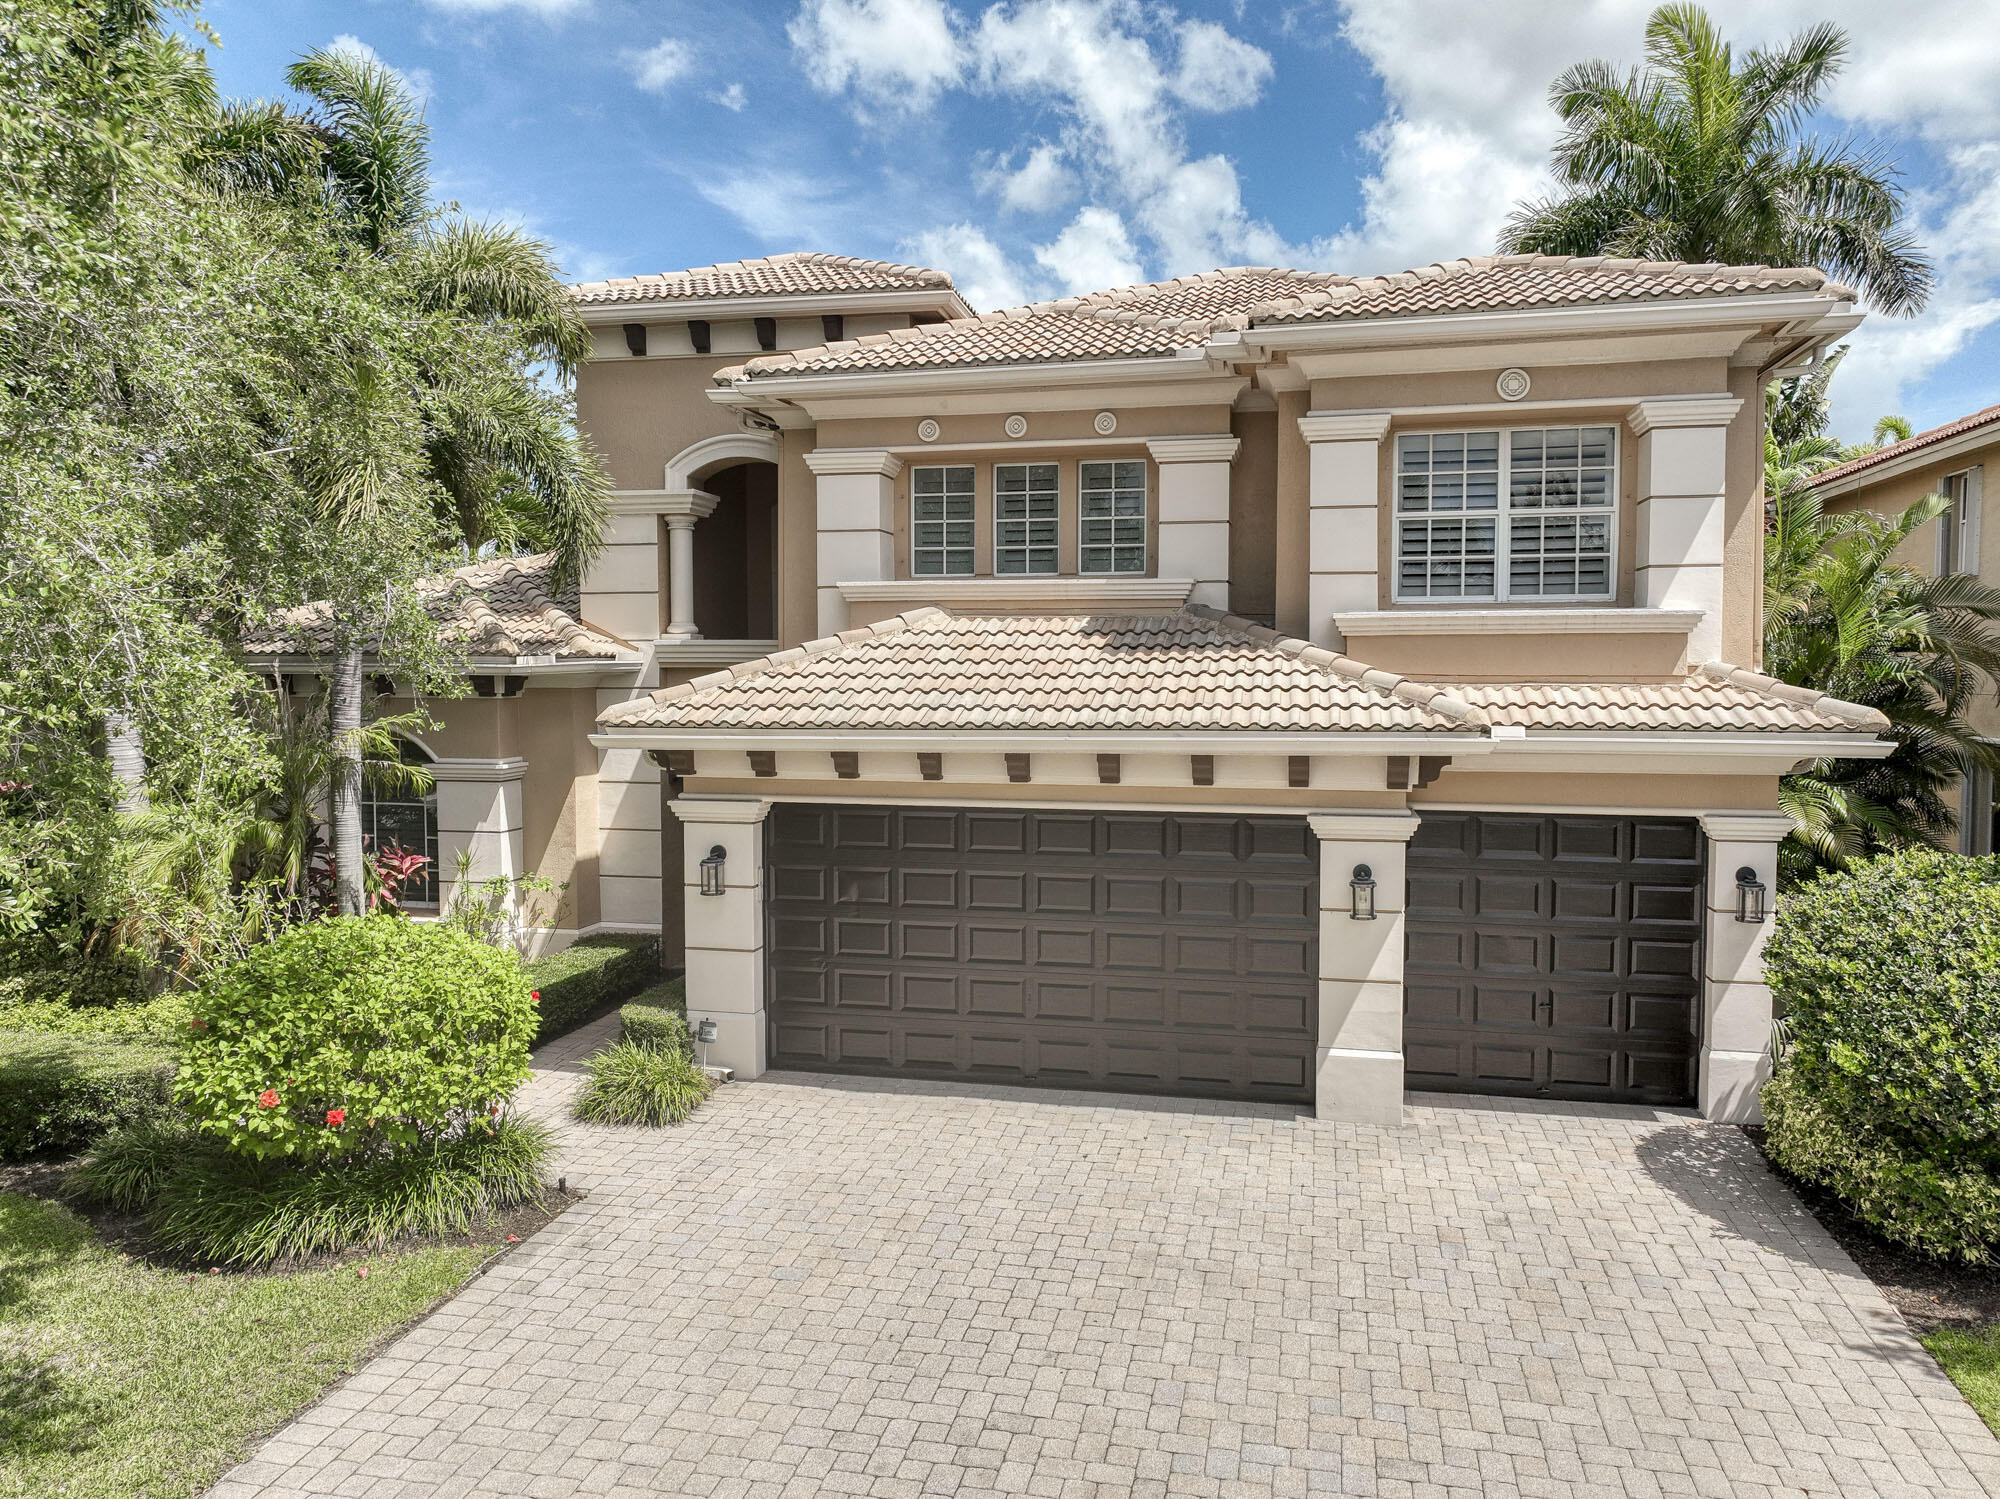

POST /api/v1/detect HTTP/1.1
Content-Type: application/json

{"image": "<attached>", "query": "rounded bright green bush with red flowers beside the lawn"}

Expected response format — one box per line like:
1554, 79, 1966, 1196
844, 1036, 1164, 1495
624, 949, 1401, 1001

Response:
174, 915, 536, 1159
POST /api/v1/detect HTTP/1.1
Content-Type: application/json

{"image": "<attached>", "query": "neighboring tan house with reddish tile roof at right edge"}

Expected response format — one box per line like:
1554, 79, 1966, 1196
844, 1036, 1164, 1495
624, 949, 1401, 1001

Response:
1812, 406, 2000, 853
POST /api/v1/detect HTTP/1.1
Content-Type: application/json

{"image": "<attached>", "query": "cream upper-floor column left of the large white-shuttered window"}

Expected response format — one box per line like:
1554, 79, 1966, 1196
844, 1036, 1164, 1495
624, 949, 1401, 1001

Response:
1298, 412, 1388, 646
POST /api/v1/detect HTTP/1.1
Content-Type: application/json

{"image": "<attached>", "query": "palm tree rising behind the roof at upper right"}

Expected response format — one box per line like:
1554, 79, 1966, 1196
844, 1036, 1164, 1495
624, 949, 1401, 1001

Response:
1500, 4, 1932, 314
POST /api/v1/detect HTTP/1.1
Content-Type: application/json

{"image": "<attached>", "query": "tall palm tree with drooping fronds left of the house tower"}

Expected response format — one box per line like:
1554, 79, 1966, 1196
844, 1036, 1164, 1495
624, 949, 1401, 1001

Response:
219, 50, 610, 913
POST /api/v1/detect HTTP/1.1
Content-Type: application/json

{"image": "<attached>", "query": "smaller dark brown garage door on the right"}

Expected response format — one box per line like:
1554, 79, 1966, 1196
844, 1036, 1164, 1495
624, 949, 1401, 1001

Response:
1404, 811, 1702, 1103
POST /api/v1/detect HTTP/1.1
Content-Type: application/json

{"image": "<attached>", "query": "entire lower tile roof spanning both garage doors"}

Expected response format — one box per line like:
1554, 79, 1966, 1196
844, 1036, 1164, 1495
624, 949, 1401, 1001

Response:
598, 606, 1886, 734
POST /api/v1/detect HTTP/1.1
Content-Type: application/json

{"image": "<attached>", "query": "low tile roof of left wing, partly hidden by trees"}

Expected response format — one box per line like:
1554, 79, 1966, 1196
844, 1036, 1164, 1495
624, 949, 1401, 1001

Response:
244, 552, 636, 662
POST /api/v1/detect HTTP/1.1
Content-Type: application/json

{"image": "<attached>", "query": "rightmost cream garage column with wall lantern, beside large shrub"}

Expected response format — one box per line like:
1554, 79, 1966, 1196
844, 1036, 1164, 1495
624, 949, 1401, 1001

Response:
1696, 811, 1792, 1123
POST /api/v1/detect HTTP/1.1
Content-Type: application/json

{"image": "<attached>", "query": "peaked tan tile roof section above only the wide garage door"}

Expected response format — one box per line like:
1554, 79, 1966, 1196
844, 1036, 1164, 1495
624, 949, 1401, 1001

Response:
600, 608, 1476, 732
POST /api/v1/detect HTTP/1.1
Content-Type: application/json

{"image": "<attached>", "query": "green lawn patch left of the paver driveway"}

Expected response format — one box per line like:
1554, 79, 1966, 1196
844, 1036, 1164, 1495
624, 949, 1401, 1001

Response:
0, 1193, 492, 1499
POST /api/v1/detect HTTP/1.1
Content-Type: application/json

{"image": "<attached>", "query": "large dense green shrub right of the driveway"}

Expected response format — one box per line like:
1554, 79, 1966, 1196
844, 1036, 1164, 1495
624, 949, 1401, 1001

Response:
1764, 849, 2000, 1261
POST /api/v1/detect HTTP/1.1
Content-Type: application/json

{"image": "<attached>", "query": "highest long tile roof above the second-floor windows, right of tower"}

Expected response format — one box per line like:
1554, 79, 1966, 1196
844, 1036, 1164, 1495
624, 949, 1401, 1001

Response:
716, 256, 1854, 384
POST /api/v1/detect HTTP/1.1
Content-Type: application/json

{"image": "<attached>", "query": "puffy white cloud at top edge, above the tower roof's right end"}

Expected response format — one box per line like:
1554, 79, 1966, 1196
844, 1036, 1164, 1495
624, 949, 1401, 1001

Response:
786, 0, 962, 112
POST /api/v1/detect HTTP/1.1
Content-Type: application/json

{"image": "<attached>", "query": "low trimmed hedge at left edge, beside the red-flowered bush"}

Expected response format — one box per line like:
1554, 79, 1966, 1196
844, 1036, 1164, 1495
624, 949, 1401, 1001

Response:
0, 1031, 174, 1161
